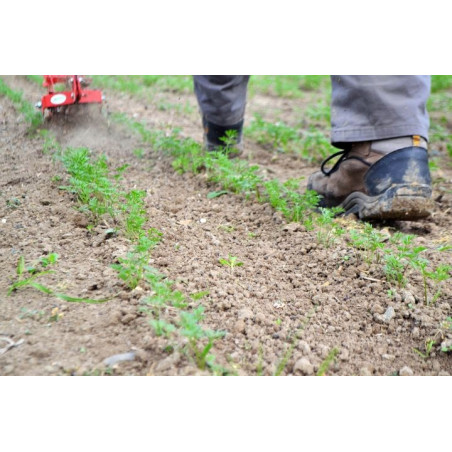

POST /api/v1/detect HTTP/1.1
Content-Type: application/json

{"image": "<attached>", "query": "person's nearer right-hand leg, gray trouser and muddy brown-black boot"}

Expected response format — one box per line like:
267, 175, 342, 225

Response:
308, 75, 431, 219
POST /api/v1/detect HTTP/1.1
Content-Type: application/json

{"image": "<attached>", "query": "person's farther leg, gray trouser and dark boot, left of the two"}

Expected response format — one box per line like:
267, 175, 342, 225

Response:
193, 75, 249, 151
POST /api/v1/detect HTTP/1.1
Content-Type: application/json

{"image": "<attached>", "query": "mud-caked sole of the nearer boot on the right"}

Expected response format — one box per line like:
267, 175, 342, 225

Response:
341, 185, 434, 221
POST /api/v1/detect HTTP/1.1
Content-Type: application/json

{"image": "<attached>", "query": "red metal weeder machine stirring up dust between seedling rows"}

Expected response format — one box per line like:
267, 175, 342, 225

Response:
38, 75, 103, 114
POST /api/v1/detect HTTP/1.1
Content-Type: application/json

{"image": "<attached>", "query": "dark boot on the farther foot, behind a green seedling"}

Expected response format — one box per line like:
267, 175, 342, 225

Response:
202, 118, 243, 158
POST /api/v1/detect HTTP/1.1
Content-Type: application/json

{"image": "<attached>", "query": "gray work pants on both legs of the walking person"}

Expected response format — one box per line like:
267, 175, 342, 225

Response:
194, 75, 430, 147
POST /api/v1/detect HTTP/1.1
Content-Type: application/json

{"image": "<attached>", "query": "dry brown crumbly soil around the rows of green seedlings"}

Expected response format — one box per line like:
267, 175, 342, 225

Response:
0, 76, 452, 376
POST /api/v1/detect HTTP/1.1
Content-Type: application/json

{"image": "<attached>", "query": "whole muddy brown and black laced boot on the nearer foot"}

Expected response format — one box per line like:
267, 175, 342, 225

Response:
308, 136, 433, 220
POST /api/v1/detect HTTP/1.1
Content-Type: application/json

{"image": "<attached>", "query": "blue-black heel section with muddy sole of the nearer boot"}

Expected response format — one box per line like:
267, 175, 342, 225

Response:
341, 147, 433, 220
